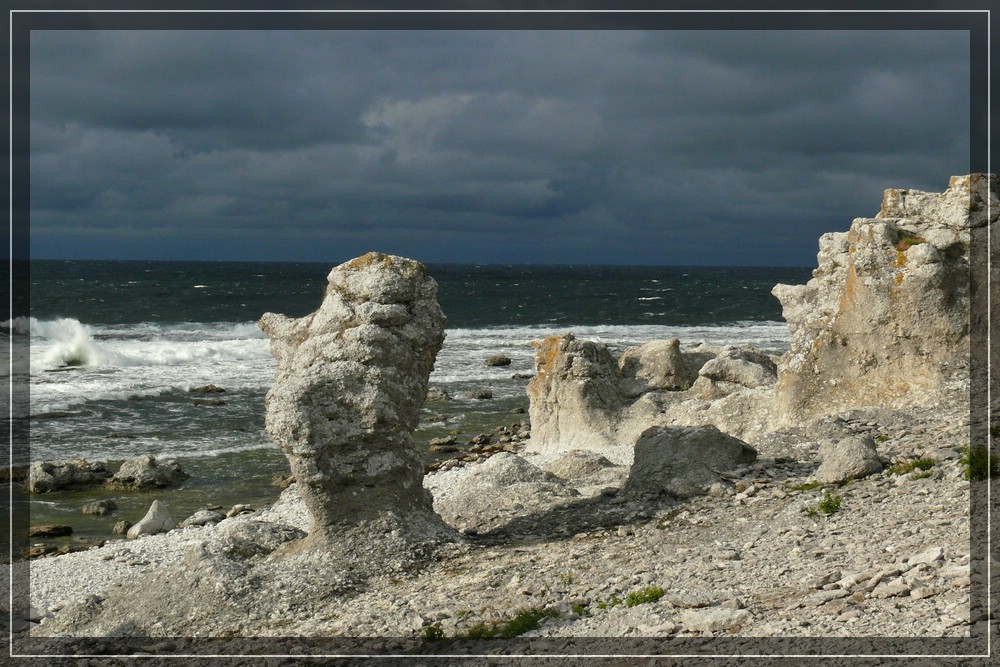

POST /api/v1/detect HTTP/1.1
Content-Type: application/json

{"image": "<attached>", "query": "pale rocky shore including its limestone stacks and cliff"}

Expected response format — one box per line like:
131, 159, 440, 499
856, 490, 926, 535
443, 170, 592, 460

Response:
7, 175, 998, 664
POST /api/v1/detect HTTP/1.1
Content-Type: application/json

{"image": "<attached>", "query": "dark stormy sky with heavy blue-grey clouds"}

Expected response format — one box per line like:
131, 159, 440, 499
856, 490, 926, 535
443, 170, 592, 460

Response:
30, 30, 970, 266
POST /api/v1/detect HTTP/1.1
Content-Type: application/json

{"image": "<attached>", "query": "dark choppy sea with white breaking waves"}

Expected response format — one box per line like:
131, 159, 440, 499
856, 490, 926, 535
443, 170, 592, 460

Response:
2, 261, 811, 541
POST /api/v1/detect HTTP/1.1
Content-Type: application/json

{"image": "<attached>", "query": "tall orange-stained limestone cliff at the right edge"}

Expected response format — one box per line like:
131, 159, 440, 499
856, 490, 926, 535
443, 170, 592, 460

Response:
772, 174, 988, 419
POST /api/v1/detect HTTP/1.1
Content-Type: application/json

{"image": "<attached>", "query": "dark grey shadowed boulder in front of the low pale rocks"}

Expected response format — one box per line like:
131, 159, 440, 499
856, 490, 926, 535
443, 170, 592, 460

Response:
622, 426, 757, 498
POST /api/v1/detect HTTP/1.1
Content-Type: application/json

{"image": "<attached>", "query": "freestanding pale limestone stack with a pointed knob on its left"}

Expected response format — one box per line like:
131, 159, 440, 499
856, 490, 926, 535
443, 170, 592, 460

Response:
259, 252, 451, 546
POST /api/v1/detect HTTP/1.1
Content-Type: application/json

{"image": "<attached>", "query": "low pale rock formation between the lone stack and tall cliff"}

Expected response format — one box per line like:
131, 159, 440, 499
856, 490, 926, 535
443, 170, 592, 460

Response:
528, 333, 775, 465
